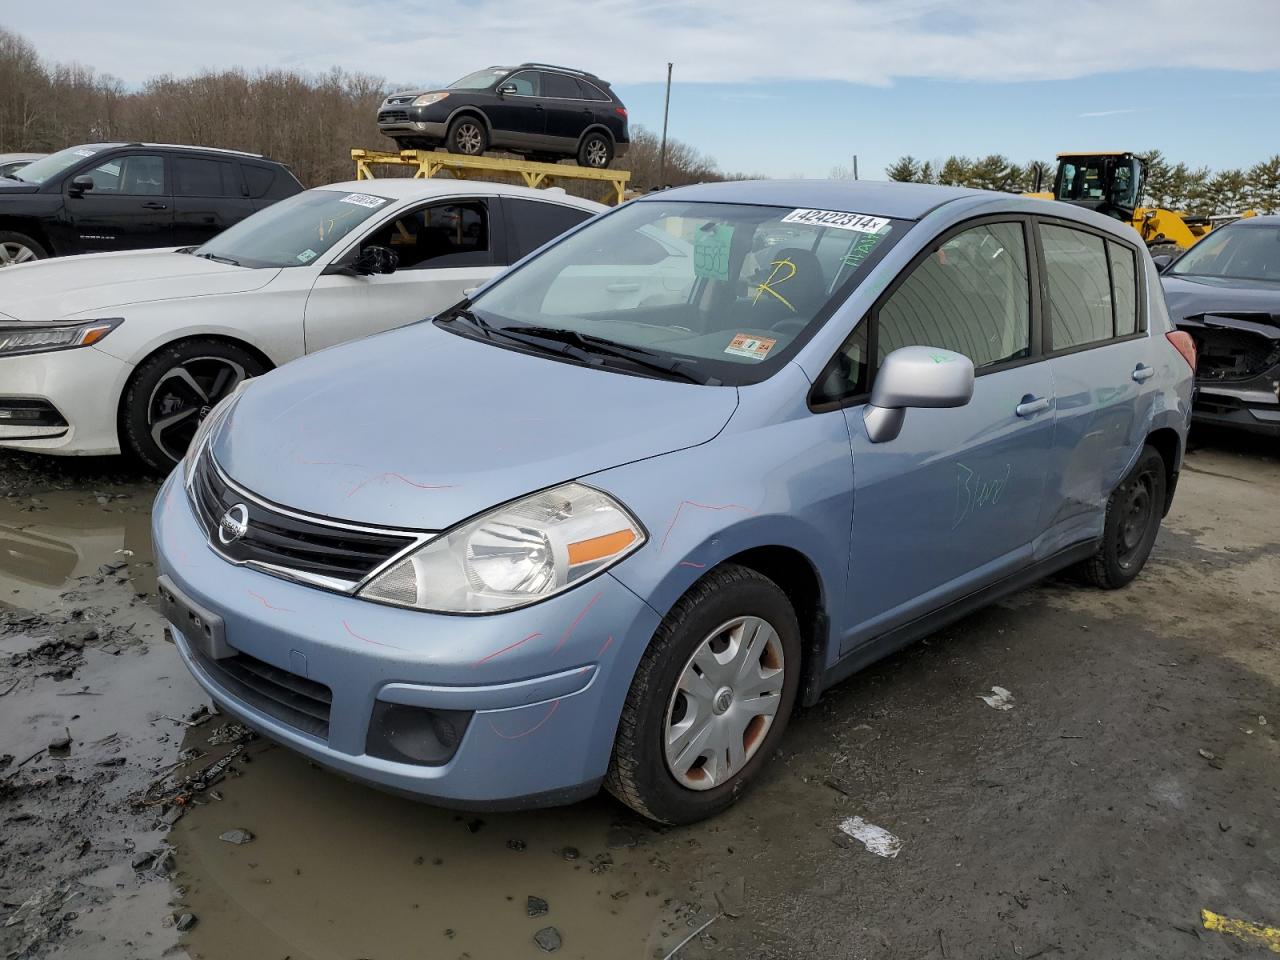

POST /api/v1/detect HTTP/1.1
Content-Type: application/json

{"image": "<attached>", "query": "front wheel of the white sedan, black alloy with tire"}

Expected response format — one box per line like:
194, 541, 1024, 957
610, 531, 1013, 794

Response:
120, 338, 266, 474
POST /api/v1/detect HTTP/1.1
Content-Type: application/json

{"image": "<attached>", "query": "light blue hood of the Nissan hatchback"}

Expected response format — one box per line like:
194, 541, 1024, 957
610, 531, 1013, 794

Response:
212, 323, 737, 530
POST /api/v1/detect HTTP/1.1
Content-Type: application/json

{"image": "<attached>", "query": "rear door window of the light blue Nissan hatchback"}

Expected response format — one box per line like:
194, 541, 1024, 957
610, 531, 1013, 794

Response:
1039, 224, 1115, 351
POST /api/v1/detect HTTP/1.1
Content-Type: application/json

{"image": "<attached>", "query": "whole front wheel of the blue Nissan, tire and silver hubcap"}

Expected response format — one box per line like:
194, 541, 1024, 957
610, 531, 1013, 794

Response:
604, 564, 801, 824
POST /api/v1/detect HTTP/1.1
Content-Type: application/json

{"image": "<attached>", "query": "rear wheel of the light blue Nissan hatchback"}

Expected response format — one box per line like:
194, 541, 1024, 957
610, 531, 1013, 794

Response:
1079, 447, 1167, 590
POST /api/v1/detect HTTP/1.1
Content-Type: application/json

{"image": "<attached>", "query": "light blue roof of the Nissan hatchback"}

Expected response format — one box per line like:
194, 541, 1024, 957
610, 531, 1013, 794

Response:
650, 180, 988, 220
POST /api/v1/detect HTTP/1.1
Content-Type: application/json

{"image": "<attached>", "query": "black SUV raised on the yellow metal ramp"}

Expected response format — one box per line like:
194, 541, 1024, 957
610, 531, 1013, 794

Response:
378, 63, 631, 166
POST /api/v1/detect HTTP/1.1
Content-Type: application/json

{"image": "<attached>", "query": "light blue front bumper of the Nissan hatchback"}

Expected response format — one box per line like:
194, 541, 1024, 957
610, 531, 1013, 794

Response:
152, 468, 658, 808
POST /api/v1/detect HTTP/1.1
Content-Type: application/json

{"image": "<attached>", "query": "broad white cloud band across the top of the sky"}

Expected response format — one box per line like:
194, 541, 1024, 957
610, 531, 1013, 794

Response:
4, 0, 1280, 85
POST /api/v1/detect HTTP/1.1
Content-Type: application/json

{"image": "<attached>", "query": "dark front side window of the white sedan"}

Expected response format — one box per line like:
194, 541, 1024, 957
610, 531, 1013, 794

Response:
362, 200, 492, 270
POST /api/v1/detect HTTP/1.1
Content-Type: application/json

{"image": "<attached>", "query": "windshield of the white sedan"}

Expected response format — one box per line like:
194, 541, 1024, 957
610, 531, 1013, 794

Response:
192, 189, 390, 266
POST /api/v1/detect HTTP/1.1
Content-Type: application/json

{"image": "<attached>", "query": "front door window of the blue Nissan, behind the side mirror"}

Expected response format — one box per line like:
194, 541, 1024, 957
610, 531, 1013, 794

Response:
876, 223, 1030, 370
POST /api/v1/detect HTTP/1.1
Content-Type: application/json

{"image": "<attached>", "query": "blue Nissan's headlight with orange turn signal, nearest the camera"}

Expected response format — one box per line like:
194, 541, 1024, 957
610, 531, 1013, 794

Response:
360, 484, 645, 613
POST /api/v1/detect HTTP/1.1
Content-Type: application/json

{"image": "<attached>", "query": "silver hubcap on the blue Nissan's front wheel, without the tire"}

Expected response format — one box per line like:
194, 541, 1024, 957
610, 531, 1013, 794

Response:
663, 617, 786, 790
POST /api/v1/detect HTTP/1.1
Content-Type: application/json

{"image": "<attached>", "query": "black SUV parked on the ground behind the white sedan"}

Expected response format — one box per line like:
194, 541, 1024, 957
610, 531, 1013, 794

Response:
0, 143, 302, 266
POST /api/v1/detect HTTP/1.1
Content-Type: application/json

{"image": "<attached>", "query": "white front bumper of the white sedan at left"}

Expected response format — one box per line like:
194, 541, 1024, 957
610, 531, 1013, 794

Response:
0, 347, 133, 454
